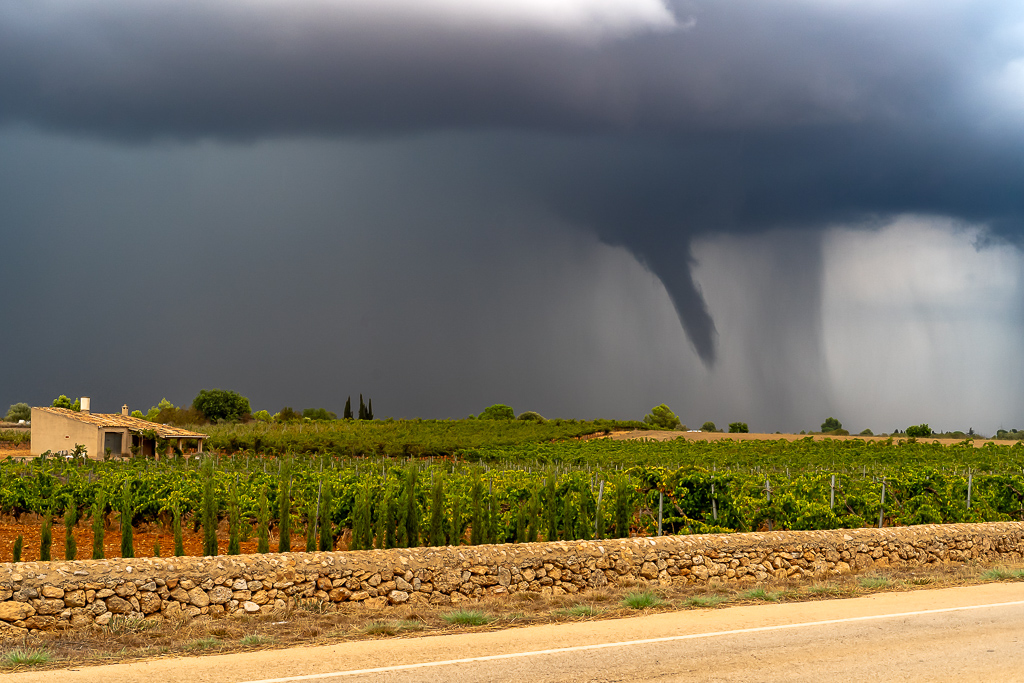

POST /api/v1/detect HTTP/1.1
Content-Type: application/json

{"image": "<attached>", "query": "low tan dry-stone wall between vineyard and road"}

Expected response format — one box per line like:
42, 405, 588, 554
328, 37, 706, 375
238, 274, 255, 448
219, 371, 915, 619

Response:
0, 522, 1024, 638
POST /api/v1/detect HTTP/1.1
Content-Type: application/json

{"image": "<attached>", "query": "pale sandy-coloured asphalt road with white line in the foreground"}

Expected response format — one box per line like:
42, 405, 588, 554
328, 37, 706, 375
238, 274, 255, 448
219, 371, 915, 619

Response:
4, 584, 1024, 683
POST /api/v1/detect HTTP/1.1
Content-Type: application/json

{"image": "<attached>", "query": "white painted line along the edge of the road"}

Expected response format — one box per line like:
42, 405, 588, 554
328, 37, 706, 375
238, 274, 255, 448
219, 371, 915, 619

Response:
240, 600, 1024, 683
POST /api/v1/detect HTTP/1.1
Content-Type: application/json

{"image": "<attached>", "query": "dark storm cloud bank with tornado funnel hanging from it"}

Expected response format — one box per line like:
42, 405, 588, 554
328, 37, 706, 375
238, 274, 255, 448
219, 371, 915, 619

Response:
0, 0, 1024, 364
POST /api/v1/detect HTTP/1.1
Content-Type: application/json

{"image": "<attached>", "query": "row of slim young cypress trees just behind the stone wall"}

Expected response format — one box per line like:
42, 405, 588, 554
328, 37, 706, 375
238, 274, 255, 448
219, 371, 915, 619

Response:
8, 457, 633, 562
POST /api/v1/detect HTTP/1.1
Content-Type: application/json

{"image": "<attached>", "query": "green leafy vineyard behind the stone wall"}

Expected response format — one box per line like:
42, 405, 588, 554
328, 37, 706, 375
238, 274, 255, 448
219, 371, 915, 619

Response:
0, 421, 1024, 565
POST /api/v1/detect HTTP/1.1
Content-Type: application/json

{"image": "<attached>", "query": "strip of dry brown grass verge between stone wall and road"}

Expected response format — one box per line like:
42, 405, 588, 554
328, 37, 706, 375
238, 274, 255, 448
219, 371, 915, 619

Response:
14, 562, 1024, 672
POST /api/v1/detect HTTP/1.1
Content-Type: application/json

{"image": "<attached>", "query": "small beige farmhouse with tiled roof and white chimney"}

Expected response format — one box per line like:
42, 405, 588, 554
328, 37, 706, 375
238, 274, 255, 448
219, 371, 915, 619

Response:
30, 398, 207, 459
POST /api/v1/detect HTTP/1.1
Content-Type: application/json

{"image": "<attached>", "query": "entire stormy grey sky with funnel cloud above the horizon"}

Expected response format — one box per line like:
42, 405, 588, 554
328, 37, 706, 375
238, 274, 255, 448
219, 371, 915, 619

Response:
0, 0, 1024, 433
